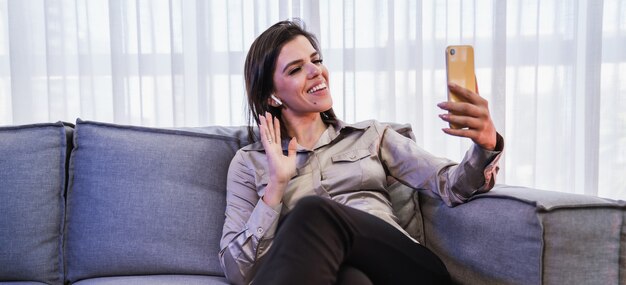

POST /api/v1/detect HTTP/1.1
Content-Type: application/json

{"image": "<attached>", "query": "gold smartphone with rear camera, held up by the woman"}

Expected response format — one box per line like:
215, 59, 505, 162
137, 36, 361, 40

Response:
446, 45, 476, 129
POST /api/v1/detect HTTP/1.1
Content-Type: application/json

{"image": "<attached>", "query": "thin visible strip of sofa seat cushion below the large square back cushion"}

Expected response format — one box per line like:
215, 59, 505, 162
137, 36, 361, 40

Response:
73, 275, 228, 285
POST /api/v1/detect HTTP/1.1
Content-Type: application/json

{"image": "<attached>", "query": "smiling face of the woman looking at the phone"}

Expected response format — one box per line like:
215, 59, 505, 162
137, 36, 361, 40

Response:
274, 36, 333, 116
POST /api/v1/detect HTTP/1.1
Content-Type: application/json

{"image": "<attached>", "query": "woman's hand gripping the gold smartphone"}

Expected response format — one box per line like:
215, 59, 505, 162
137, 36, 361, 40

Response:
437, 83, 497, 150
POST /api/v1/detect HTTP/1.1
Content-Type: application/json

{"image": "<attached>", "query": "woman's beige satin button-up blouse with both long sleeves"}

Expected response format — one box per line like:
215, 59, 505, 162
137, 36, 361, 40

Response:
220, 118, 503, 284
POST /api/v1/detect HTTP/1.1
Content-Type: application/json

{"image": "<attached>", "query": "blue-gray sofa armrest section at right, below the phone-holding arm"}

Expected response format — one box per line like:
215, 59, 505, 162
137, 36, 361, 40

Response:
419, 185, 626, 285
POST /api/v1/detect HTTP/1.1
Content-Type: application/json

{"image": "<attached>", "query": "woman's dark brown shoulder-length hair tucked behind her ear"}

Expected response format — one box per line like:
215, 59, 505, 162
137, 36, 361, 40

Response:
244, 19, 337, 142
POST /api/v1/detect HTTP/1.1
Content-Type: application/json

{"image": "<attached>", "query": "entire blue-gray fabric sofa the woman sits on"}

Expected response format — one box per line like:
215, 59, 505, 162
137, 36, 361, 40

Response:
0, 120, 626, 285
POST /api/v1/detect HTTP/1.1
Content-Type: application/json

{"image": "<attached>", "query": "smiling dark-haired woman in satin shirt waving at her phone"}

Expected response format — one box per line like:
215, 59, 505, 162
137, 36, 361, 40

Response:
220, 18, 503, 284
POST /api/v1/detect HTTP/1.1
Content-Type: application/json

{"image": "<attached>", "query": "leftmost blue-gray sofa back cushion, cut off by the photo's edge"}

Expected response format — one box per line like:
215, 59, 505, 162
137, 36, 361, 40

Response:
0, 123, 71, 284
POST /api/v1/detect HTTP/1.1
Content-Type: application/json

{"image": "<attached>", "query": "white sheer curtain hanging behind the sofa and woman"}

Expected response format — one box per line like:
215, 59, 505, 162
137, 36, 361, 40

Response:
0, 0, 626, 199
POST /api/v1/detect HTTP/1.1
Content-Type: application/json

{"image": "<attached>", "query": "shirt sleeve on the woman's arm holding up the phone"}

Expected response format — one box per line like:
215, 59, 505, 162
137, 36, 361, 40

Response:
380, 123, 504, 206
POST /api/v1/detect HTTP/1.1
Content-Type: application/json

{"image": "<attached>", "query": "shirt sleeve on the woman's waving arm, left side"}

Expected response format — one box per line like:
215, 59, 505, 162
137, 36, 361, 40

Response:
219, 151, 282, 284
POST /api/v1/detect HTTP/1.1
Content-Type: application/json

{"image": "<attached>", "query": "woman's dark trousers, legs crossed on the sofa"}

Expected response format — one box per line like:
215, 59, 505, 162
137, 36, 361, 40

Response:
254, 197, 450, 285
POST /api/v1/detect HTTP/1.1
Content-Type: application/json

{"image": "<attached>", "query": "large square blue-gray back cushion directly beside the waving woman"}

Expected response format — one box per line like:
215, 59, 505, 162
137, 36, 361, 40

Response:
65, 120, 245, 282
